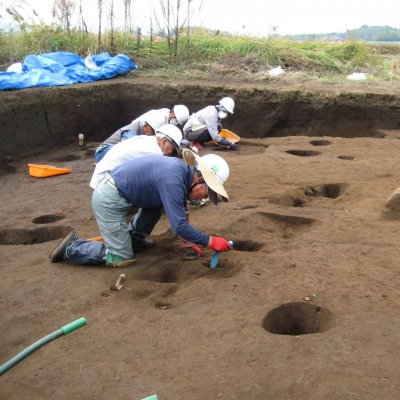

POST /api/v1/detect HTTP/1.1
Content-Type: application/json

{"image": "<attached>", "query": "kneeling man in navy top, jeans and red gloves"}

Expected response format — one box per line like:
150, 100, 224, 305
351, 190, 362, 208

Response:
49, 149, 230, 267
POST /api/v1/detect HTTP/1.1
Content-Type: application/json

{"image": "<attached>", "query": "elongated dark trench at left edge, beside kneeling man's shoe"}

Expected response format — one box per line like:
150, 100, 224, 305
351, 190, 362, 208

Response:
0, 226, 72, 245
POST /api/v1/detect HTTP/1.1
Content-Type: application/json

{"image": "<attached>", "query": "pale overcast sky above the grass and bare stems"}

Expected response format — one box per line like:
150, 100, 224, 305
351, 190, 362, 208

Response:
0, 0, 400, 36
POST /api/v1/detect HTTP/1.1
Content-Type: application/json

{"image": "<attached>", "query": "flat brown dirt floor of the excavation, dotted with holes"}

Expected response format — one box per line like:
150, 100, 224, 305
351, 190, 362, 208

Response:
0, 74, 400, 400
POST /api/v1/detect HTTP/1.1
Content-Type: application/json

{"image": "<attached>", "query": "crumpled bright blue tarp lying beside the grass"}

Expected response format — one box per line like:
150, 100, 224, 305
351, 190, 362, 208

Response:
0, 51, 138, 90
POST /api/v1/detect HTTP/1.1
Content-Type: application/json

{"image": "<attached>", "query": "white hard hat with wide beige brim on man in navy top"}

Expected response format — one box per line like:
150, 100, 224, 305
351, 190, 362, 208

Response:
196, 154, 229, 205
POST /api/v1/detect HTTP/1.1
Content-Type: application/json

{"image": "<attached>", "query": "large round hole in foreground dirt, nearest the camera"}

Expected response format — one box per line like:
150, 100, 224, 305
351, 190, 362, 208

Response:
262, 301, 336, 336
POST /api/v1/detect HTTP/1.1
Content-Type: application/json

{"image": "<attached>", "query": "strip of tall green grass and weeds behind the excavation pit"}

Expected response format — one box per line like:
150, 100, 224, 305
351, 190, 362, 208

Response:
0, 25, 400, 79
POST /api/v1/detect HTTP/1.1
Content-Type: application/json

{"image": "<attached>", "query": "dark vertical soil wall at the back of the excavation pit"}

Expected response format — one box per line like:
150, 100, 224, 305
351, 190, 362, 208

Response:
0, 78, 400, 157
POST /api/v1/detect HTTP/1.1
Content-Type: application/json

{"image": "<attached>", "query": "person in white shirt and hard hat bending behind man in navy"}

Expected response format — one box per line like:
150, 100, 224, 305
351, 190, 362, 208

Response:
90, 124, 182, 189
